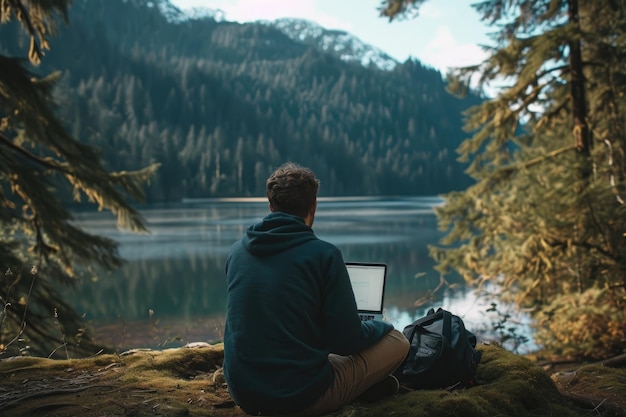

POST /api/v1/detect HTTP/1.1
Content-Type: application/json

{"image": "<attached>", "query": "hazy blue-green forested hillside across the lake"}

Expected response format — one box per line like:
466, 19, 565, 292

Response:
0, 0, 478, 201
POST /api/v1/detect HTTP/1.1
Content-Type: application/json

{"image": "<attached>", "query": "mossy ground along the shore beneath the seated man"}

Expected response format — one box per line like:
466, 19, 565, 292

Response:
0, 344, 626, 417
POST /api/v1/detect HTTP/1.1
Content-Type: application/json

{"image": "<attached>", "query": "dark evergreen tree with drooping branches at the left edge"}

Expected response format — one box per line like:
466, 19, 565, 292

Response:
0, 0, 156, 357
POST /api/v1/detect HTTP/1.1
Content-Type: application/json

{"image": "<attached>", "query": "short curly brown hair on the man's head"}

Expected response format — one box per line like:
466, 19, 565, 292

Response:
266, 162, 320, 218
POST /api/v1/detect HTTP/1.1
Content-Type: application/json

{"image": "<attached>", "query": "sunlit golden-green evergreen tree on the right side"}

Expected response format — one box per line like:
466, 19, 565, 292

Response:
381, 0, 626, 357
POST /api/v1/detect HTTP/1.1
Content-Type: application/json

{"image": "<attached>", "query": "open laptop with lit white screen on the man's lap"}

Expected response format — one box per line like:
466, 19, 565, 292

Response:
346, 262, 387, 320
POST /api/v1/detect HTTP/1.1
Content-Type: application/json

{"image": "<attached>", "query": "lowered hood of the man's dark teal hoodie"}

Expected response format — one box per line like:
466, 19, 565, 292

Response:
241, 212, 317, 256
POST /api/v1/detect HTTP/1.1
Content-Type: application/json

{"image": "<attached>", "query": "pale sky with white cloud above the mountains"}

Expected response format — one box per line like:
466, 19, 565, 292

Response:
170, 0, 489, 74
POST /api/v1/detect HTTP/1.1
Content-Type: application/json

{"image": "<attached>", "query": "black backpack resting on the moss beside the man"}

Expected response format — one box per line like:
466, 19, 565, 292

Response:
394, 308, 481, 389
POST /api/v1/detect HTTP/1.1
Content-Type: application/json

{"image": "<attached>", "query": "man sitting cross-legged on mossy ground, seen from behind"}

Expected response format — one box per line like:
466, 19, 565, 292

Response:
224, 163, 409, 416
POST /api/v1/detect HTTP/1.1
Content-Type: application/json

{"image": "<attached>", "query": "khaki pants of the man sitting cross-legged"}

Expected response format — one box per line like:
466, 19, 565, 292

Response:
297, 329, 409, 417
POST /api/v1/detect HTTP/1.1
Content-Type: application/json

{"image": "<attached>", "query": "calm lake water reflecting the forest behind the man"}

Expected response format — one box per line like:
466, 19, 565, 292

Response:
68, 197, 532, 347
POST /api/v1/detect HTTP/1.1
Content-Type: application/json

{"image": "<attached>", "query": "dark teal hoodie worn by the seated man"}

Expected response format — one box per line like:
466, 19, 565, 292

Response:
224, 212, 393, 414
